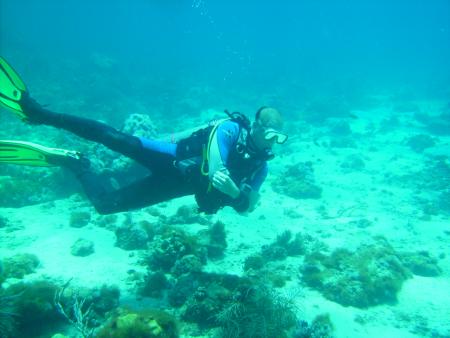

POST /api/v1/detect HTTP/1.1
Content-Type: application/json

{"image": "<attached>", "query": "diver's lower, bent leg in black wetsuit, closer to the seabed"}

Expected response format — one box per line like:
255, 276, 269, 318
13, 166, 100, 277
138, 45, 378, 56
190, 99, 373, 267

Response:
78, 173, 194, 215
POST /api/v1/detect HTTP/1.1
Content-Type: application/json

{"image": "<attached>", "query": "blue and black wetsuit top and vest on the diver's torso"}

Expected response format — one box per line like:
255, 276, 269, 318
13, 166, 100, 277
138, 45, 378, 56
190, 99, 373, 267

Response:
141, 120, 268, 213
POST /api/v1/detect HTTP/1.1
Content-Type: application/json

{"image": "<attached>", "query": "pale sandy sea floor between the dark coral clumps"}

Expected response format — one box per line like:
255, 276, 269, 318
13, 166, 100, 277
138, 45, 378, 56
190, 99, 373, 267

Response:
0, 99, 450, 338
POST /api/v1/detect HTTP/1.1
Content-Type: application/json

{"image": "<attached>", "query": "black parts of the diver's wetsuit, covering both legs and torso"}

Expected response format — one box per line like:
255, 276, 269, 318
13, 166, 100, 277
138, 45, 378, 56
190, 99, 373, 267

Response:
30, 106, 267, 214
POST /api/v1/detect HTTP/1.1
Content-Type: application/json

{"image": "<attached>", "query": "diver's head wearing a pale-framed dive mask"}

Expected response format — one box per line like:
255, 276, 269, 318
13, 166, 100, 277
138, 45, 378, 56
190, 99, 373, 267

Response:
249, 107, 288, 152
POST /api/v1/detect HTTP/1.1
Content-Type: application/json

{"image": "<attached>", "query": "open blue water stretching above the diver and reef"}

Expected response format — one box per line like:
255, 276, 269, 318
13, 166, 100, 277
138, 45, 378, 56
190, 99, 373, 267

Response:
0, 0, 450, 118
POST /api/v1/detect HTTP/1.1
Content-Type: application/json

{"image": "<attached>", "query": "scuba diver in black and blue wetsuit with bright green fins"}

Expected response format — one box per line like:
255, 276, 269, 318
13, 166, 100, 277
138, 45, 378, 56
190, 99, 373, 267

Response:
0, 57, 288, 214
